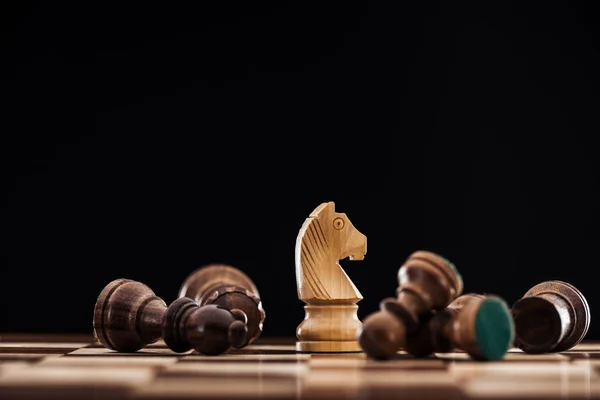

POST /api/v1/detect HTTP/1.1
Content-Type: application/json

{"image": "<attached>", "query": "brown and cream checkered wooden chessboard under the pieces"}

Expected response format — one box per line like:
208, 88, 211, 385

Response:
0, 334, 600, 400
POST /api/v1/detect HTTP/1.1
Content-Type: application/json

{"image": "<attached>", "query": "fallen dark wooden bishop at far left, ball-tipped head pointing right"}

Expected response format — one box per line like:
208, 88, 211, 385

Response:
94, 279, 248, 355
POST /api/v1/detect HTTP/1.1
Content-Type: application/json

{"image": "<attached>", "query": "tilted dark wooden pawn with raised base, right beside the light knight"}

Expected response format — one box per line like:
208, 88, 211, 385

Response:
358, 251, 463, 359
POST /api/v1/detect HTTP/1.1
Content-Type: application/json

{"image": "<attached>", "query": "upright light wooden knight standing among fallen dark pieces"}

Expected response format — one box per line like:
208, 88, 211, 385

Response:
296, 202, 367, 352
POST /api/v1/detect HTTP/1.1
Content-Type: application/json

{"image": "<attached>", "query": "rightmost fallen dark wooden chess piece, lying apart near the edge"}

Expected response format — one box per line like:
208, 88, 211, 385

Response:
512, 280, 591, 353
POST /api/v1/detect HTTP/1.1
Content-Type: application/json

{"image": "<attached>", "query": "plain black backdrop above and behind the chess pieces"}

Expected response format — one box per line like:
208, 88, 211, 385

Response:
0, 1, 600, 339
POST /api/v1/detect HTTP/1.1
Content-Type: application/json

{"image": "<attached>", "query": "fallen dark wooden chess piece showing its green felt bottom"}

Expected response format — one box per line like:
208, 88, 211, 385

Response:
405, 293, 515, 361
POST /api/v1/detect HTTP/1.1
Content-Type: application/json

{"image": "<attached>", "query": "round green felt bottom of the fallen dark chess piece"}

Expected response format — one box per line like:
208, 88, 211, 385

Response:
475, 298, 515, 361
